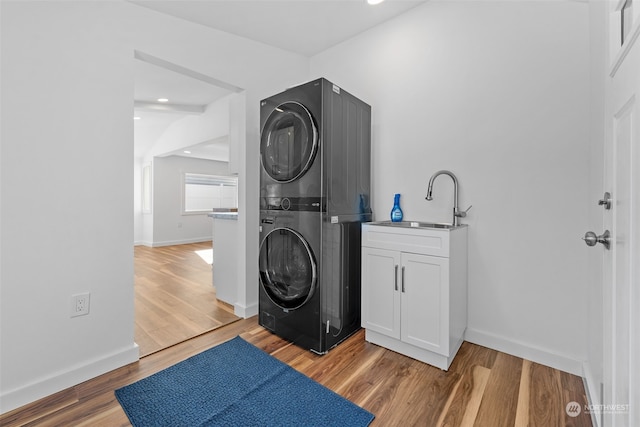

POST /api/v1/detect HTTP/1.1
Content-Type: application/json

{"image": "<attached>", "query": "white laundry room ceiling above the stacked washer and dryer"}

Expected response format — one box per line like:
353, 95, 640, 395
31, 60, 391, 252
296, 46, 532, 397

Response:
131, 0, 426, 56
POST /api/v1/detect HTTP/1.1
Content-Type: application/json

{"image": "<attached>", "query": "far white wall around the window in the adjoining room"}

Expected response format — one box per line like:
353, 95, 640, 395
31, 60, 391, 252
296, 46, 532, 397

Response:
149, 156, 229, 246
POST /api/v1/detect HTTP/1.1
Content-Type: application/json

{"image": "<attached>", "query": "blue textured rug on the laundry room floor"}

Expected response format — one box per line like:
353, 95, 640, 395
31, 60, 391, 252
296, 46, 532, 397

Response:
116, 337, 374, 427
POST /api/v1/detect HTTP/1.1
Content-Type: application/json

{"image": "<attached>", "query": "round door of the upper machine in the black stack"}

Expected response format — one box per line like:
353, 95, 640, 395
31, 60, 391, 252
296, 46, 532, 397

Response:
260, 101, 318, 183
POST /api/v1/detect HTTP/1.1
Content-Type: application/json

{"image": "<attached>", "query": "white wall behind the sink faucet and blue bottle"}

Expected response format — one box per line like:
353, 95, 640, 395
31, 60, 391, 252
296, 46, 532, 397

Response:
311, 1, 590, 374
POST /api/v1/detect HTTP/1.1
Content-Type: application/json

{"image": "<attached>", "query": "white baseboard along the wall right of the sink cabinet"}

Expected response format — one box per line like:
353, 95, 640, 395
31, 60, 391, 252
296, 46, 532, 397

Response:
465, 328, 583, 377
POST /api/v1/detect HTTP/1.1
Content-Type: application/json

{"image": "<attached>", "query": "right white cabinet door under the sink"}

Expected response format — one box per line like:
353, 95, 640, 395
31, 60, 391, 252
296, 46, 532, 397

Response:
400, 253, 449, 356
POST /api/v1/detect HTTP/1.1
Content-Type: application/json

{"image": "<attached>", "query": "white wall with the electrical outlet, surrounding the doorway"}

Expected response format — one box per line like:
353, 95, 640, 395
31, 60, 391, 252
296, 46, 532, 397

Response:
0, 1, 309, 412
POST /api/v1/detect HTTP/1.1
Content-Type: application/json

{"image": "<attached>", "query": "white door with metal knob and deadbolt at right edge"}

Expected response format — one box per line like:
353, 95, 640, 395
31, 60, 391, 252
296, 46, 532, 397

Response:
602, 1, 640, 427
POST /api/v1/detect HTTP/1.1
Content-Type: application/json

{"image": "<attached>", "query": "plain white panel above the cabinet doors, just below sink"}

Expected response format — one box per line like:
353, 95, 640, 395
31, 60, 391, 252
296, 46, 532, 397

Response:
362, 224, 449, 258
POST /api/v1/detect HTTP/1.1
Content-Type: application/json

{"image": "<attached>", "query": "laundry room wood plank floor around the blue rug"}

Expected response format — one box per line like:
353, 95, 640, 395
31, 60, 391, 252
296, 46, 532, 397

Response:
0, 317, 591, 427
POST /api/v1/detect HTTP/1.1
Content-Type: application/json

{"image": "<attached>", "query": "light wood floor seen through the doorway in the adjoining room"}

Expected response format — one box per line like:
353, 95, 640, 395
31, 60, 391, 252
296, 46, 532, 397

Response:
134, 242, 239, 357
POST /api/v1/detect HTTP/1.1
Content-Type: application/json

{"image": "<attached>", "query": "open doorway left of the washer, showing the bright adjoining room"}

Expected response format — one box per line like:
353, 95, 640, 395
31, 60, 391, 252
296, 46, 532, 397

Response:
133, 51, 243, 357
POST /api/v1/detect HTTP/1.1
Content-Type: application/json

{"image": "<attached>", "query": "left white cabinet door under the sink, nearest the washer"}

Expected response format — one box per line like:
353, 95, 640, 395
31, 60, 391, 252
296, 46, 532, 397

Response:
362, 247, 400, 339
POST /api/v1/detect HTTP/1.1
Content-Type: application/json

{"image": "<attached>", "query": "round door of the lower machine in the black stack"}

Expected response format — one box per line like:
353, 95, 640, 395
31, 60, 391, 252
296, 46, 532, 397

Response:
259, 228, 318, 310
